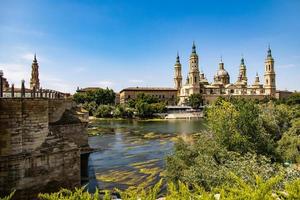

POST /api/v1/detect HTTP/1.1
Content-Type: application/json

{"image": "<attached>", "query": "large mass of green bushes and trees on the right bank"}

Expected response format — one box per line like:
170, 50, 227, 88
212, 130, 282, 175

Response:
166, 99, 300, 191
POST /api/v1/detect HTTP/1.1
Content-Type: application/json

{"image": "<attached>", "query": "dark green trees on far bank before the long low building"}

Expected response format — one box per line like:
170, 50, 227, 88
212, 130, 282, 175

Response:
73, 88, 167, 118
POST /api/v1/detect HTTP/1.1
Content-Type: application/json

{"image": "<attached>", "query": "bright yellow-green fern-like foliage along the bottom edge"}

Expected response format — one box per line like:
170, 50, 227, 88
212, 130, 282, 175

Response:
1, 174, 300, 200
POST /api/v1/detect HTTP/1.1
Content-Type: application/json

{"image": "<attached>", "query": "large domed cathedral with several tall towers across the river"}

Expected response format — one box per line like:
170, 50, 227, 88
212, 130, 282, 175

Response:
174, 43, 276, 105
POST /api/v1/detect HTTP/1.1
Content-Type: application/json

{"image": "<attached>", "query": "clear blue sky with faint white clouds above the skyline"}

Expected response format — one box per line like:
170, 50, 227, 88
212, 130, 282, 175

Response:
0, 0, 300, 93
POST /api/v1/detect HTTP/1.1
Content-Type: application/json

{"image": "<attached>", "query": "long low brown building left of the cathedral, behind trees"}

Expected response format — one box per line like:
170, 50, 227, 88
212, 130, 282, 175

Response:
120, 87, 177, 105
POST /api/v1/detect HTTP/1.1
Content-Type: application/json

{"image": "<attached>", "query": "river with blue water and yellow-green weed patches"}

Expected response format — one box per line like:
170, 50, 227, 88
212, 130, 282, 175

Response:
88, 120, 205, 191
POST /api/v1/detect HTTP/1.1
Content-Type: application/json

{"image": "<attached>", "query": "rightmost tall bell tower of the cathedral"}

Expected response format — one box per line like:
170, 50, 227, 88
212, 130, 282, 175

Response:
264, 46, 276, 96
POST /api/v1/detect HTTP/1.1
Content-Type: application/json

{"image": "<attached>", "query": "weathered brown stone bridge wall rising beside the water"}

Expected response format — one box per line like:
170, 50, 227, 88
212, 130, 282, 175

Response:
0, 98, 88, 199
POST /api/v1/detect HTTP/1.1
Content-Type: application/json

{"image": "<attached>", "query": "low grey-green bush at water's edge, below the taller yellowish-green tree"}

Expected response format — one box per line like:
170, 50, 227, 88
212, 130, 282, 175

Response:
166, 133, 280, 190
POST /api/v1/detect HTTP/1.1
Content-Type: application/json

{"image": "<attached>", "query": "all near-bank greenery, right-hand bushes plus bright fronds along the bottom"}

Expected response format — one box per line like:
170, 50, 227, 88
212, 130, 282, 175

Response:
2, 93, 300, 199
